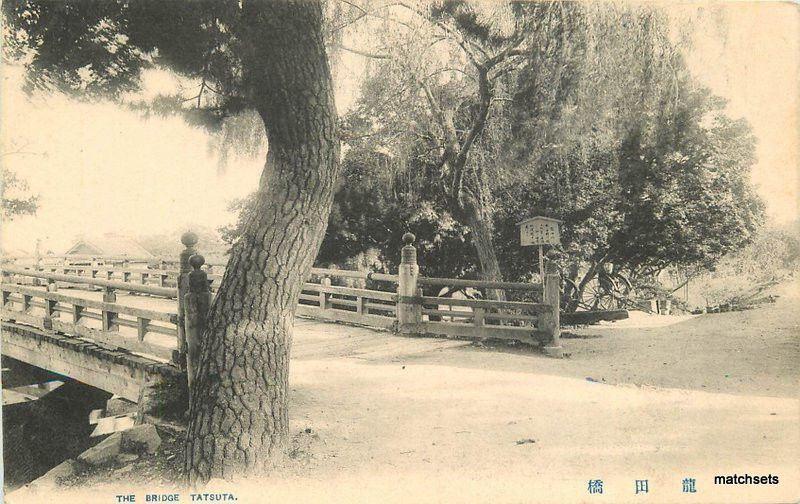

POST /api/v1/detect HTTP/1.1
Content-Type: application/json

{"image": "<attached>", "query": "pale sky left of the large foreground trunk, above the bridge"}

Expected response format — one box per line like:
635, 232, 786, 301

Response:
1, 69, 263, 253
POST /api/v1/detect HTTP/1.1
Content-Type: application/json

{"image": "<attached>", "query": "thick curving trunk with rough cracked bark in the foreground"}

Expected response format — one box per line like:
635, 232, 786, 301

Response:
185, 0, 339, 484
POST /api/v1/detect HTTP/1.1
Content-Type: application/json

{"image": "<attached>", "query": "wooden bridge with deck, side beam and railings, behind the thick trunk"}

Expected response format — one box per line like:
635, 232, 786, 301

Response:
0, 233, 561, 412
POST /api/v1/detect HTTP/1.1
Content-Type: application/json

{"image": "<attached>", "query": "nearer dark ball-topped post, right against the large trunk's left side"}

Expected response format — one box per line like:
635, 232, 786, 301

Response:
184, 254, 211, 397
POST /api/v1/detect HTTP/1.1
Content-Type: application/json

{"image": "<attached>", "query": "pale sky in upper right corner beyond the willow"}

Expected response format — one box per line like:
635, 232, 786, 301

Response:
673, 2, 800, 223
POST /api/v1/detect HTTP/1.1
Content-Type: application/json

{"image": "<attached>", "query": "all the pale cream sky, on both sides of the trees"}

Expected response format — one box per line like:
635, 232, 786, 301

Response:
0, 2, 800, 253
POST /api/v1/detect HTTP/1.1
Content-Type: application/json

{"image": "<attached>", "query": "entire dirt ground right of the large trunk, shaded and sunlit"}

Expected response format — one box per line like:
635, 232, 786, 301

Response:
276, 284, 800, 502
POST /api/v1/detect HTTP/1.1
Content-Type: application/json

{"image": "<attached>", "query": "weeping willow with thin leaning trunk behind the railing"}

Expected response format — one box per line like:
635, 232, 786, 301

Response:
336, 1, 700, 294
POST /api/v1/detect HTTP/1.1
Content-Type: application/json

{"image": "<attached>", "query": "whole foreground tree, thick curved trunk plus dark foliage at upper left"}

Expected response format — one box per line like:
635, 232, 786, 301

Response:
3, 0, 339, 482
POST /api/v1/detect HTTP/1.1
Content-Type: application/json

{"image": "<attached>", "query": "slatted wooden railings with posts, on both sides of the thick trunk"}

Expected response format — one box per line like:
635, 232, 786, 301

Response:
0, 233, 561, 374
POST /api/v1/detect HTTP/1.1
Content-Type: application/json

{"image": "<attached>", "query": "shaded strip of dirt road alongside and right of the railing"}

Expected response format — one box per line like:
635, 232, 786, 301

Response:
293, 283, 800, 398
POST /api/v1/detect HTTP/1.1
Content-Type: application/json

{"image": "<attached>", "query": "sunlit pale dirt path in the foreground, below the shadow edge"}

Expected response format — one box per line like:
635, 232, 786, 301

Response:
37, 358, 800, 503
